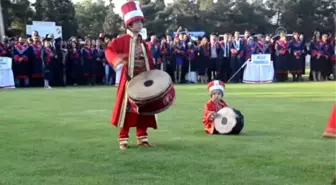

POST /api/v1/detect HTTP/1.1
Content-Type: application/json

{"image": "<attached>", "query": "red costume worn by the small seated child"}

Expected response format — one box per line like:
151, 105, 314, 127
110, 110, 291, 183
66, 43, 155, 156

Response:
202, 99, 228, 134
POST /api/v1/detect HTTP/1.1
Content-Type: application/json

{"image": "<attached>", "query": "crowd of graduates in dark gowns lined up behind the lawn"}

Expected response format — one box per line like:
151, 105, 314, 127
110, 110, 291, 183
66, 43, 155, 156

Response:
0, 27, 336, 88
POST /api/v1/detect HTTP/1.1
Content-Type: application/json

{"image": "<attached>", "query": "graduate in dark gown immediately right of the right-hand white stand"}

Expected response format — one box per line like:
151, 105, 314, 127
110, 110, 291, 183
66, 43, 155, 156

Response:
275, 32, 290, 82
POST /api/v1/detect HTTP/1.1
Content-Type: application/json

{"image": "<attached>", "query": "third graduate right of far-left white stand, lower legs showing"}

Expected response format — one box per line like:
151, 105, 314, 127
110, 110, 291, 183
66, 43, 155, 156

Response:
41, 38, 58, 89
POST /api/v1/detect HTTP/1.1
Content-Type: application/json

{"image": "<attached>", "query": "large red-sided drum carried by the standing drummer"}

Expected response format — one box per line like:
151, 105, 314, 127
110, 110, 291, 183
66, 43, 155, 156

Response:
127, 69, 175, 115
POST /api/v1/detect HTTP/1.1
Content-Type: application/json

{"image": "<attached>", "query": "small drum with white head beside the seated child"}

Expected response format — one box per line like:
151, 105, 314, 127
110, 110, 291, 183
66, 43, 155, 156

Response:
214, 107, 244, 135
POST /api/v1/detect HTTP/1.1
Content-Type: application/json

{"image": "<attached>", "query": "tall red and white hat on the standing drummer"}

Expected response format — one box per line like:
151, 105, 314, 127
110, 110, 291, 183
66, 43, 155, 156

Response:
121, 0, 145, 26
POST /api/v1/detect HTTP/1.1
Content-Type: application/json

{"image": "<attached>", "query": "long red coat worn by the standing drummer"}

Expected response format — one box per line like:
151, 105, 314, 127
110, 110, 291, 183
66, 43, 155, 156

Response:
105, 34, 157, 129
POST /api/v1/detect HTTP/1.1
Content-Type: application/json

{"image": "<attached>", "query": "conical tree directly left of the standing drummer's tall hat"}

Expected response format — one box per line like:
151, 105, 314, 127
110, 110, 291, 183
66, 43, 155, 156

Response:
103, 3, 123, 34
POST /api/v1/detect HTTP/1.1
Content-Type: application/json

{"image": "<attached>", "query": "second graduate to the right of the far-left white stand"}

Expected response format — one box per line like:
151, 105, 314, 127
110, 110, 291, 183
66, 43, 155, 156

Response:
31, 32, 43, 86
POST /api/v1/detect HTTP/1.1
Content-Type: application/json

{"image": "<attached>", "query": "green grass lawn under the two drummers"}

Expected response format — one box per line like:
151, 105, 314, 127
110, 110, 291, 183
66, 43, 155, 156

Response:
0, 82, 336, 185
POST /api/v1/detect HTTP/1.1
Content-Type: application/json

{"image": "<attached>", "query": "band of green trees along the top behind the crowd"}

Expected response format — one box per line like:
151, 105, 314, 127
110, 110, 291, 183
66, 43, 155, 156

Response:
1, 0, 336, 37
